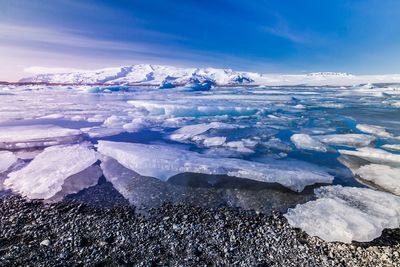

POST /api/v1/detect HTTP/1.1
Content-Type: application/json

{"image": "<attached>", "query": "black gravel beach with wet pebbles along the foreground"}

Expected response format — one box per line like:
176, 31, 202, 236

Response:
0, 196, 400, 266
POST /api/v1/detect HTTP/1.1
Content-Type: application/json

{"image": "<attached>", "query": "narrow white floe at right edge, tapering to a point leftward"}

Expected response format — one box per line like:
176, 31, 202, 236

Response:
339, 147, 400, 166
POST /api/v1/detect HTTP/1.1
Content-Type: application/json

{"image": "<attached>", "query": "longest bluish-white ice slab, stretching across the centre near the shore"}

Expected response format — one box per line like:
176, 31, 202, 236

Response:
98, 141, 333, 191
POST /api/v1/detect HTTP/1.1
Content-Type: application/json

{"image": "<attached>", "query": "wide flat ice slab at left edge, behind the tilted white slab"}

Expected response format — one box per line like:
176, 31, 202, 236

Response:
0, 125, 81, 149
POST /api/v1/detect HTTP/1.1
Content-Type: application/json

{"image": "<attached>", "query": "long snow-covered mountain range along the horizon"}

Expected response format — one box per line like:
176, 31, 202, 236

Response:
19, 64, 400, 88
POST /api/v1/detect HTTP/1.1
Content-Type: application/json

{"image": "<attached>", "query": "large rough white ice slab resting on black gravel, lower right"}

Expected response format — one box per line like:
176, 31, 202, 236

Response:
285, 186, 400, 243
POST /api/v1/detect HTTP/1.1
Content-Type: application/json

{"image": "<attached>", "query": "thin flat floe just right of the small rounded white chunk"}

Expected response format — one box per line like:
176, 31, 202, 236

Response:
315, 134, 375, 147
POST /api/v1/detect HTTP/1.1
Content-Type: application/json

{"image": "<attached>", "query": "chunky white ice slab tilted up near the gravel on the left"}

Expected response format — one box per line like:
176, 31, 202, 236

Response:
4, 144, 98, 199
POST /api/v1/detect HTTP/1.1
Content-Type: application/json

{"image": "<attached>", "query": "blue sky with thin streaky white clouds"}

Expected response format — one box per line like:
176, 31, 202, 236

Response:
0, 0, 400, 81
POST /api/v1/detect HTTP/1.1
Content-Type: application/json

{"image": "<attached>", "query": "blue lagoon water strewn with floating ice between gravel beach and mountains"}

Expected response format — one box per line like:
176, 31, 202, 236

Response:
0, 86, 400, 216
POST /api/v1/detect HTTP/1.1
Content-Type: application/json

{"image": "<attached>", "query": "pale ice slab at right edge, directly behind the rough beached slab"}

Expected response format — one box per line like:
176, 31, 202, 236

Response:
354, 164, 400, 196
